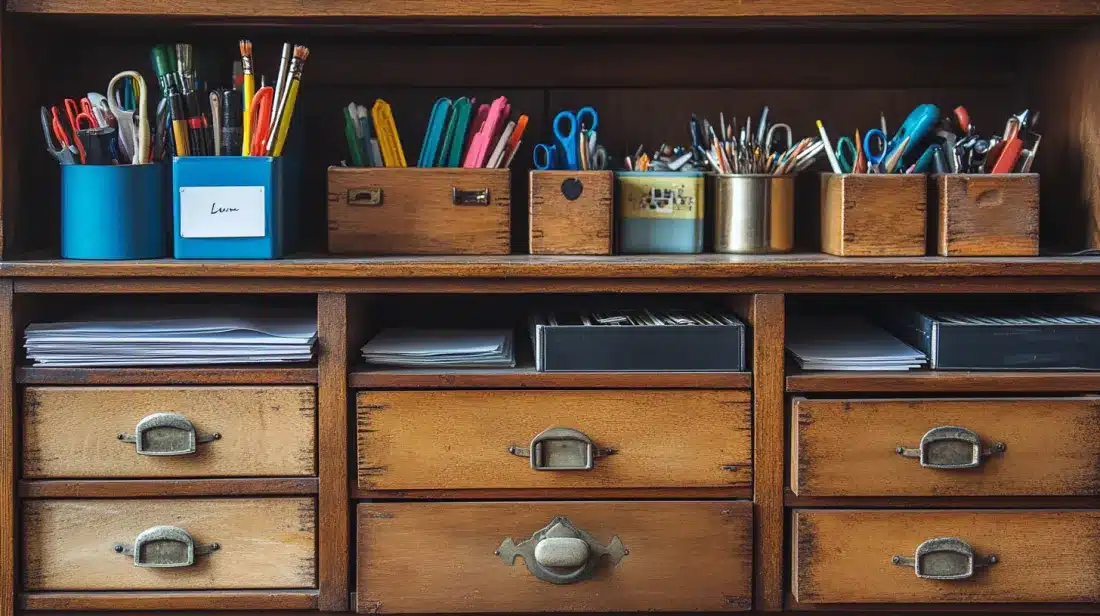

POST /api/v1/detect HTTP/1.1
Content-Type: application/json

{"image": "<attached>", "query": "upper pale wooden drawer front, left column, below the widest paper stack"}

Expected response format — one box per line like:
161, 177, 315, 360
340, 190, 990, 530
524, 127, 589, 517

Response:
23, 386, 317, 479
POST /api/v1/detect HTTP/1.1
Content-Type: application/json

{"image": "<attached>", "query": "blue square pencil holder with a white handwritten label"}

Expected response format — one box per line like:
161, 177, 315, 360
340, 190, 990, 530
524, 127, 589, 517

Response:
172, 156, 287, 259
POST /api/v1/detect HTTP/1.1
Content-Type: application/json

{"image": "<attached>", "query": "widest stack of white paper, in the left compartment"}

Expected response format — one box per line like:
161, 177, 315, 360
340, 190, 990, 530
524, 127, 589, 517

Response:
25, 317, 317, 366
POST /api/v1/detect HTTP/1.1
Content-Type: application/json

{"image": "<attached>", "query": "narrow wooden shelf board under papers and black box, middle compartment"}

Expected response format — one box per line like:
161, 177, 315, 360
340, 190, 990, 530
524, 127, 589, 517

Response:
348, 366, 752, 389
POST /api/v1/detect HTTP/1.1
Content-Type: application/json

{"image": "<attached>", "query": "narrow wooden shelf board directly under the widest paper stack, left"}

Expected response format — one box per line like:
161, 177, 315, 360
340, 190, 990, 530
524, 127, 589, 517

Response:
15, 365, 317, 385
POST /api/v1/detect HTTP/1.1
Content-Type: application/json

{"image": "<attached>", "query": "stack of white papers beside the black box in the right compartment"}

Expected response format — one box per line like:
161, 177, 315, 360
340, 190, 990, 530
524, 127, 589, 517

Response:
787, 317, 928, 371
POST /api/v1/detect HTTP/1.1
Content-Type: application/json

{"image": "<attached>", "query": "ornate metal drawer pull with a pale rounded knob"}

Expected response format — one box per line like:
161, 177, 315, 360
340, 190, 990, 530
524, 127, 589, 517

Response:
495, 516, 630, 584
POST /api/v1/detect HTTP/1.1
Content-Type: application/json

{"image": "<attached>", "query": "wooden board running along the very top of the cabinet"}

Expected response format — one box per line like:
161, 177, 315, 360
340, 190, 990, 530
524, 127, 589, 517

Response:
7, 0, 1100, 18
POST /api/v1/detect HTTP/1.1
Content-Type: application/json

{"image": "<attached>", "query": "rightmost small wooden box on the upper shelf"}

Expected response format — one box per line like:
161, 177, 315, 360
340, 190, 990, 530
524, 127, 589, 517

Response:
933, 174, 1038, 256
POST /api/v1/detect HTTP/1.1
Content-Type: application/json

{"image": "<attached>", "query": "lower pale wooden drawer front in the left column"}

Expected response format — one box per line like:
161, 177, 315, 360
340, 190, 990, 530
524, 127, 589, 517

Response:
23, 498, 317, 591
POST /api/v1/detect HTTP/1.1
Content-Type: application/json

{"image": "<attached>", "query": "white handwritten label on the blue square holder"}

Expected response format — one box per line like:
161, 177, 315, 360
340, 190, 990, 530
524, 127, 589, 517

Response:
179, 186, 267, 239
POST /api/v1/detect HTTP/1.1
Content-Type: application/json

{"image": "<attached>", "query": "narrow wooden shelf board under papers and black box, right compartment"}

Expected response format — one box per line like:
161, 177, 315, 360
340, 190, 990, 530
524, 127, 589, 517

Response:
787, 370, 1100, 393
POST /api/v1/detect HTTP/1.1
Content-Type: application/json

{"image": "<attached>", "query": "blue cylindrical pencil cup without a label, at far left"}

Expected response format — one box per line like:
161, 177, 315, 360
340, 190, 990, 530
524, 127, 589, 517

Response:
62, 163, 168, 260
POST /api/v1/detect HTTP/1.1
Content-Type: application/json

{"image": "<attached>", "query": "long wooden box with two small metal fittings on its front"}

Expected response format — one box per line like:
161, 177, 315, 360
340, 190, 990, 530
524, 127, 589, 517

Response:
329, 167, 512, 254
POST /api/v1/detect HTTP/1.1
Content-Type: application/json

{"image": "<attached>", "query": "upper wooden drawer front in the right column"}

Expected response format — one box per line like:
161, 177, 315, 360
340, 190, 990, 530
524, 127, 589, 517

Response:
791, 397, 1100, 496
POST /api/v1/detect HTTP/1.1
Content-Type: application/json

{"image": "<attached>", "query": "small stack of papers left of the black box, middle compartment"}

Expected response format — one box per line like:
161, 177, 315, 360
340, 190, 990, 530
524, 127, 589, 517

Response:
363, 329, 516, 367
